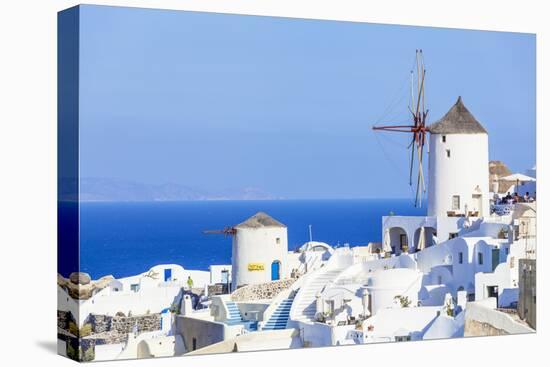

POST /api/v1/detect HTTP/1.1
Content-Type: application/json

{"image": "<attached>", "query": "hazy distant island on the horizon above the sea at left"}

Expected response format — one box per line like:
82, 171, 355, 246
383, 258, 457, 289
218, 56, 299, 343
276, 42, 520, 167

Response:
59, 178, 284, 202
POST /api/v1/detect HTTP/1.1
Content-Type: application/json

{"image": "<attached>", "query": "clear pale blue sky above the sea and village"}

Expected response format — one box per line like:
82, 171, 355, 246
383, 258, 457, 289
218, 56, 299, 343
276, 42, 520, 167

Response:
76, 6, 535, 198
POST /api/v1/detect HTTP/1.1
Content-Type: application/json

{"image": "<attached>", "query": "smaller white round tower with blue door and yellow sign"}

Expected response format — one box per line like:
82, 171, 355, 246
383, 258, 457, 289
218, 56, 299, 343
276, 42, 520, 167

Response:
232, 212, 288, 290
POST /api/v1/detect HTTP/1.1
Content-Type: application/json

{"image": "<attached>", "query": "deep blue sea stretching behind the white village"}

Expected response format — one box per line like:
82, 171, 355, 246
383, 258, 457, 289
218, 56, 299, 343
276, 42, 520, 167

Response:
80, 199, 425, 279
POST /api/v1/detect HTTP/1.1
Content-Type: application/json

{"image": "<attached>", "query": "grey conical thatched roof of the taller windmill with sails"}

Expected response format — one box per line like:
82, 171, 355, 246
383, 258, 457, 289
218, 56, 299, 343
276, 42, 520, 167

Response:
428, 97, 487, 134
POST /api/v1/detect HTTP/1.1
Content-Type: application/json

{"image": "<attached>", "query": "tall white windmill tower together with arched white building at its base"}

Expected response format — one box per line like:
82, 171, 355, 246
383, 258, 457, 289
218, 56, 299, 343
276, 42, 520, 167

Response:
382, 97, 490, 254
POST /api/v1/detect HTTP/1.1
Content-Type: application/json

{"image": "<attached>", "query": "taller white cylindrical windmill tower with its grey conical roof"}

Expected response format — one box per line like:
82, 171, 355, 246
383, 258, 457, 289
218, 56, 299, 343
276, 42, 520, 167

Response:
428, 97, 490, 217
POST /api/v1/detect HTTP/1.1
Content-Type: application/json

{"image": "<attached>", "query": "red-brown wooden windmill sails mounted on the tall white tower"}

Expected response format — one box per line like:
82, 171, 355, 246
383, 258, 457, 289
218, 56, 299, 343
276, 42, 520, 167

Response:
372, 49, 428, 207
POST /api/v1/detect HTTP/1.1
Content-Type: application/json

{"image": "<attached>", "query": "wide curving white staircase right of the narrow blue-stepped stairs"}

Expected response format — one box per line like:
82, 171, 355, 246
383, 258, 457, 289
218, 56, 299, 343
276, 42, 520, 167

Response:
290, 268, 344, 323
